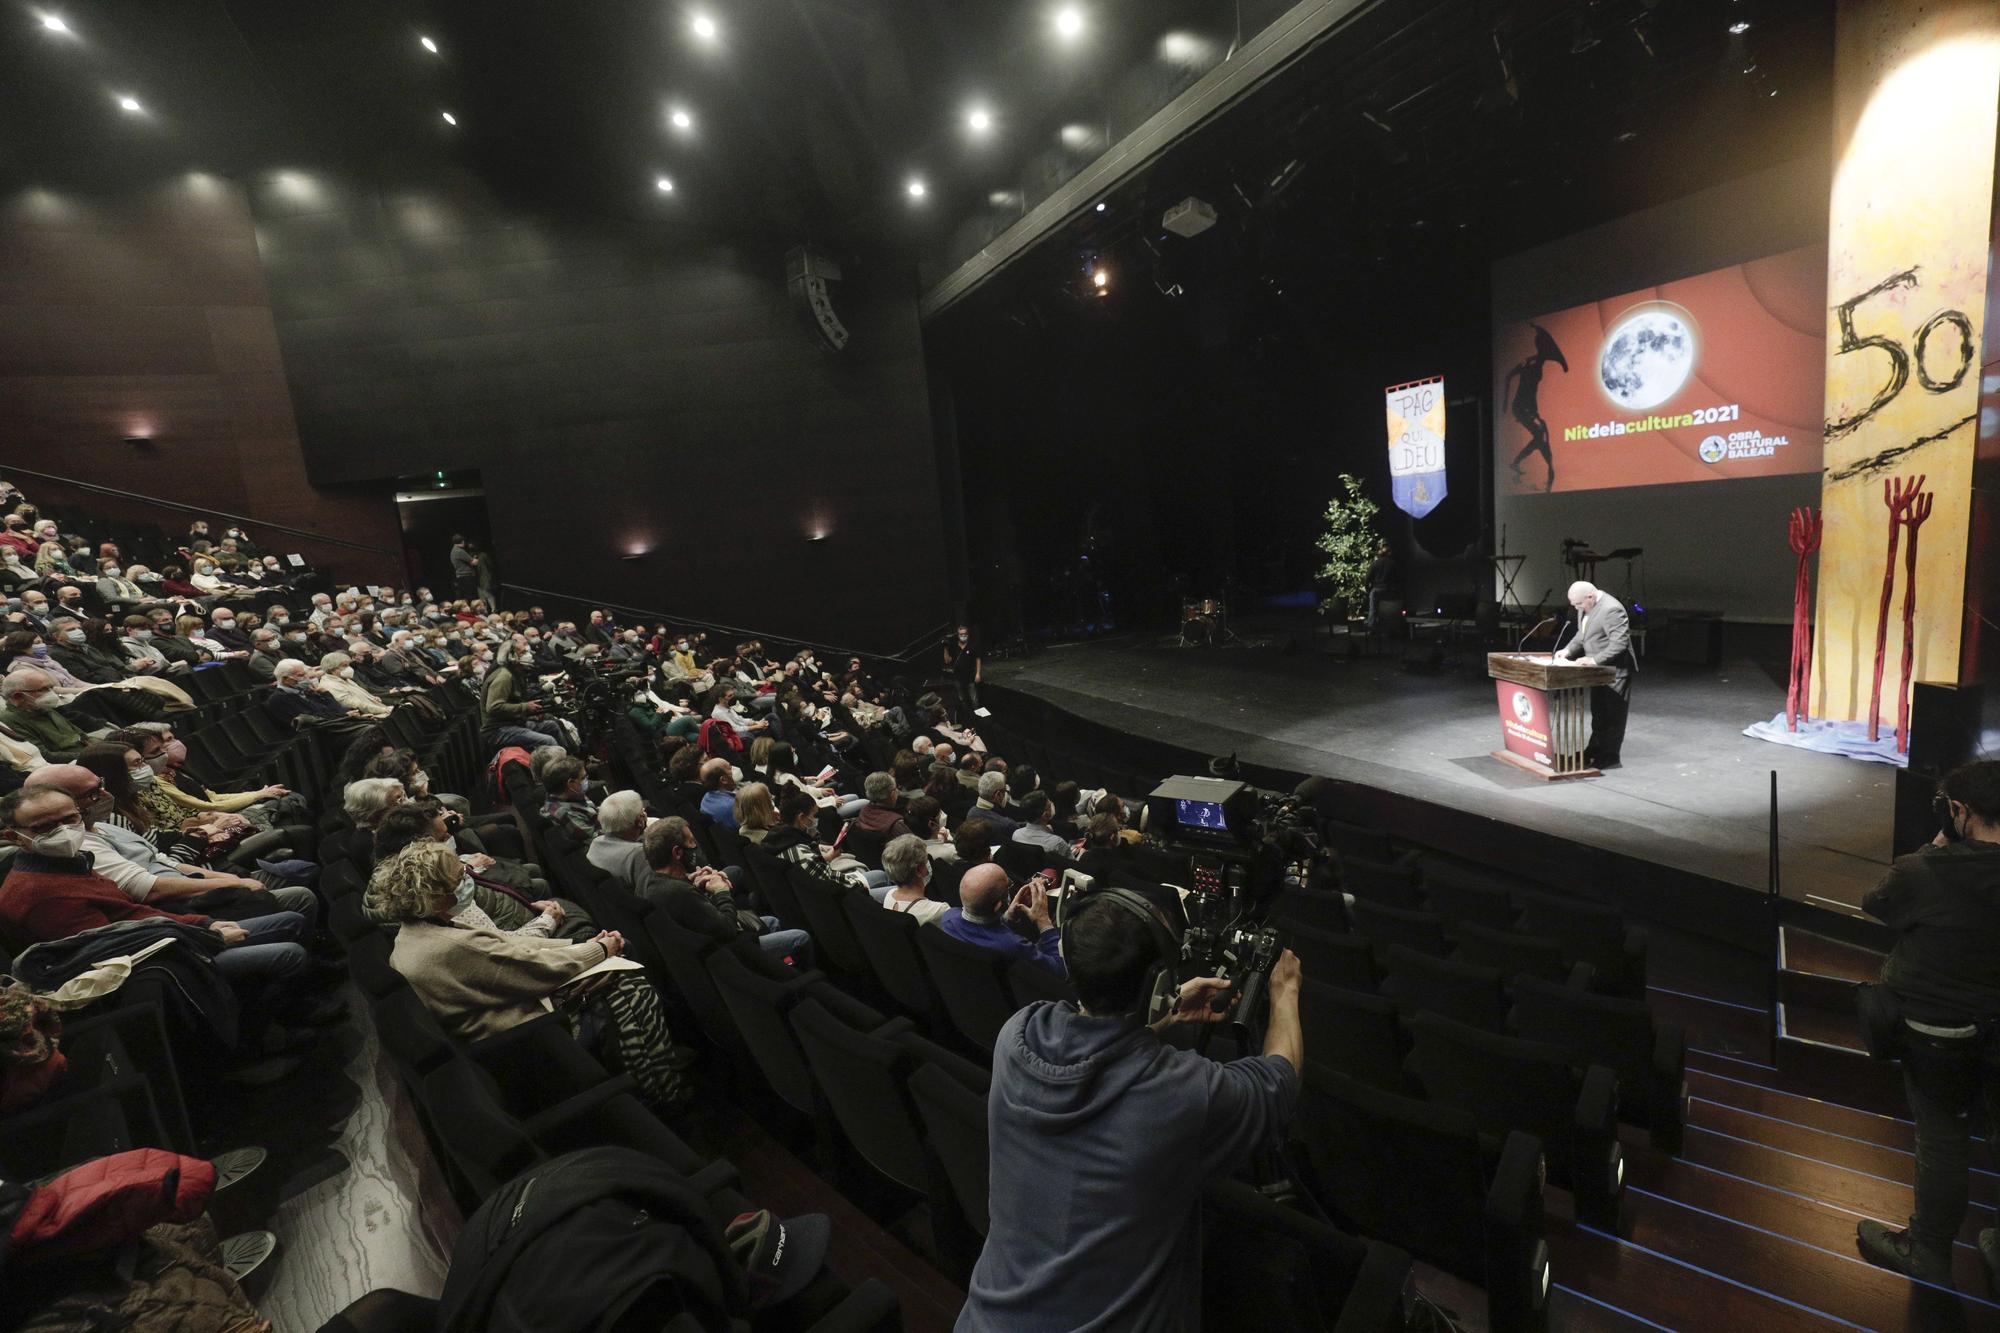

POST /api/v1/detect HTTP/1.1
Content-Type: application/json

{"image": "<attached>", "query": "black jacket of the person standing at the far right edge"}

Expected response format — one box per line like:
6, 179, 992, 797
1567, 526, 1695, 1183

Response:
1862, 839, 2000, 1025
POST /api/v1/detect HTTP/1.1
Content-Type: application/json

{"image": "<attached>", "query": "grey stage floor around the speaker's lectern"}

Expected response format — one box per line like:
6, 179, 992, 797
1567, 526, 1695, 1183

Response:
986, 636, 1896, 913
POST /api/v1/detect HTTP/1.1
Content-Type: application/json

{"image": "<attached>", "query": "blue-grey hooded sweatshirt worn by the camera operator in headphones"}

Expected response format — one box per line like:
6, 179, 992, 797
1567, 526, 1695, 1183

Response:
958, 1001, 1298, 1333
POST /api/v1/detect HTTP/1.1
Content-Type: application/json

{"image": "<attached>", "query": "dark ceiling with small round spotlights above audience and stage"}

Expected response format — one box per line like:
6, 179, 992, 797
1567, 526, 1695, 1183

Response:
0, 0, 1832, 304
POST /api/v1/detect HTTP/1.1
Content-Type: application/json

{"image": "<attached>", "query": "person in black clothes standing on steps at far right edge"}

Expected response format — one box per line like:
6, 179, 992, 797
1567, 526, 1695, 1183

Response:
1856, 761, 2000, 1287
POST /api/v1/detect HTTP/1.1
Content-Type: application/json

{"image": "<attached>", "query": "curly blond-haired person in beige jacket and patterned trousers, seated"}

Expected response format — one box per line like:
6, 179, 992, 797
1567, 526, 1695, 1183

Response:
368, 841, 694, 1115
